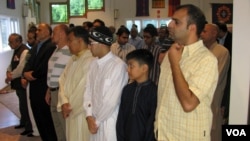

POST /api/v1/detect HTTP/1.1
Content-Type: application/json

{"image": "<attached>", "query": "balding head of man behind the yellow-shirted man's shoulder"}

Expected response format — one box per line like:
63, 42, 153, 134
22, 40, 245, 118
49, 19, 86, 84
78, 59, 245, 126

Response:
201, 24, 218, 48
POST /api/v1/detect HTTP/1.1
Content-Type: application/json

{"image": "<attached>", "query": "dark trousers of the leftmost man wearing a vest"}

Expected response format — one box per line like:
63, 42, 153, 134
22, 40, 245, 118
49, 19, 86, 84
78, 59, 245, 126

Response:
16, 89, 32, 131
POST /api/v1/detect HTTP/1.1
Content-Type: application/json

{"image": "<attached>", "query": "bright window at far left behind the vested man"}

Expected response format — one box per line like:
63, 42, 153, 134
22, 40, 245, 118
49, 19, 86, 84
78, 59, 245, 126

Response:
0, 15, 20, 52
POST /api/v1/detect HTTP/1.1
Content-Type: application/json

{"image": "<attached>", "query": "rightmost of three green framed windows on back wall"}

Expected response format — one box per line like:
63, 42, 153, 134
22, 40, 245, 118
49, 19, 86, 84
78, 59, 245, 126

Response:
88, 0, 105, 11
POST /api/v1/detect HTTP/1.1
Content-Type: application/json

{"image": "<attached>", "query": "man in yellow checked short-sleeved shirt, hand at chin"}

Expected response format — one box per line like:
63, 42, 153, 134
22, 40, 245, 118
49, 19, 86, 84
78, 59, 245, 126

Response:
154, 4, 218, 141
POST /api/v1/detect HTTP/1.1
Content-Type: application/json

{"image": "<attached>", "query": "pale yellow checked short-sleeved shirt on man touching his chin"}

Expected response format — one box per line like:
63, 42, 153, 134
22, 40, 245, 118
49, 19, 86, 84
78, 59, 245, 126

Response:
155, 40, 218, 141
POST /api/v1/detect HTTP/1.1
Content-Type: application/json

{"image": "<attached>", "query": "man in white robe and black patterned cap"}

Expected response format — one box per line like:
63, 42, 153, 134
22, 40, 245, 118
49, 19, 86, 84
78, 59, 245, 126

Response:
84, 26, 128, 141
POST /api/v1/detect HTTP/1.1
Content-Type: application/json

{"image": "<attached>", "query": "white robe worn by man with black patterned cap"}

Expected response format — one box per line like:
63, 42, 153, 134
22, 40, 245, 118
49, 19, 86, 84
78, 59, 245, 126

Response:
84, 52, 128, 141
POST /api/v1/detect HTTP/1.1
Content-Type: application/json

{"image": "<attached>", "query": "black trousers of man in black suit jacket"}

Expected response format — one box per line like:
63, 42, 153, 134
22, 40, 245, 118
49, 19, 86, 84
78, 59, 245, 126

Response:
30, 91, 57, 141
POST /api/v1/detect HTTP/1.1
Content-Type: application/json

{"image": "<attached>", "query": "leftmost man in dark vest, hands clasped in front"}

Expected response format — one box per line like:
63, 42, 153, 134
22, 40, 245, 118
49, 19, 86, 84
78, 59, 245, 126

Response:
5, 33, 32, 135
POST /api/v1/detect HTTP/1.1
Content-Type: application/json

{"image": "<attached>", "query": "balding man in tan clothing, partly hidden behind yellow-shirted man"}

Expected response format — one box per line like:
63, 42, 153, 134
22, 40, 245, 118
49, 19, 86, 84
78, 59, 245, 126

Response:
201, 24, 230, 141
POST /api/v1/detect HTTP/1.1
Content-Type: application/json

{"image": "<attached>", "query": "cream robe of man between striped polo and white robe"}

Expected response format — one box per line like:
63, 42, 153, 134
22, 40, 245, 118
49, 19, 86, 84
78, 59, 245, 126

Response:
57, 50, 93, 141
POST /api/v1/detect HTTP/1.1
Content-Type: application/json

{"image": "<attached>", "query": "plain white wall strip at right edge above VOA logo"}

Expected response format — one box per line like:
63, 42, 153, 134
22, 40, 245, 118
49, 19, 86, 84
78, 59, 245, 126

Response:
229, 0, 250, 124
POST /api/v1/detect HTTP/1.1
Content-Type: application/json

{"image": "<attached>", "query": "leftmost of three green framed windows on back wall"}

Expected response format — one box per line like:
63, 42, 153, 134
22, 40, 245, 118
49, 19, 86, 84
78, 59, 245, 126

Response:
50, 2, 69, 24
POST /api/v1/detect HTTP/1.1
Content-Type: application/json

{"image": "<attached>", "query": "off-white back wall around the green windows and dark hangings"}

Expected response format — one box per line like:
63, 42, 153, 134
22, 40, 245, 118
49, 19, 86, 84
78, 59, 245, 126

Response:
40, 0, 233, 27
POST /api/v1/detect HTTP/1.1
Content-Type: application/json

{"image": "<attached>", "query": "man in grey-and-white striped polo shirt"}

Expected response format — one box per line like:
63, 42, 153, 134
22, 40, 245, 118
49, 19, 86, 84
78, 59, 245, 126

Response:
45, 24, 71, 141
